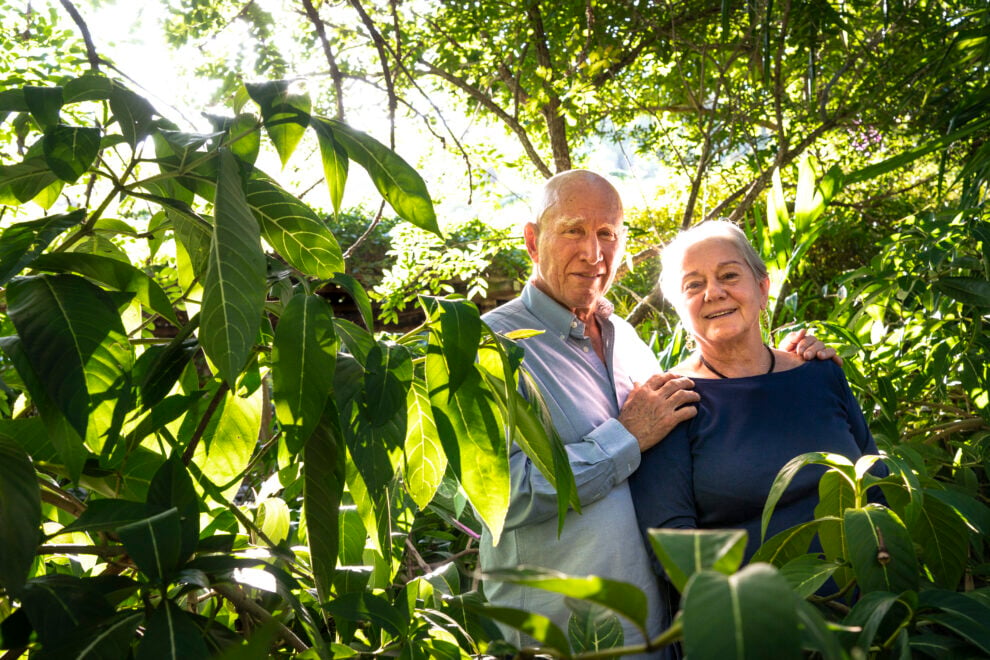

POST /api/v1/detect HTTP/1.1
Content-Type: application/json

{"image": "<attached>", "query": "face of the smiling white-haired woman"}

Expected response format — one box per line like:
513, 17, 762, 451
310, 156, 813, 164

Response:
677, 238, 770, 348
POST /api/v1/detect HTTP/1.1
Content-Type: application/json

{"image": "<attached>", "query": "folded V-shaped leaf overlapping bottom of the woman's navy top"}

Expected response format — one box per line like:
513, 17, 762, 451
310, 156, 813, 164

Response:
648, 529, 746, 592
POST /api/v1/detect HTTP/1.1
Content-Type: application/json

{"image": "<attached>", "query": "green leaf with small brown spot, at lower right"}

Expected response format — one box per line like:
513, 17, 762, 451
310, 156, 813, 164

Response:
842, 505, 918, 593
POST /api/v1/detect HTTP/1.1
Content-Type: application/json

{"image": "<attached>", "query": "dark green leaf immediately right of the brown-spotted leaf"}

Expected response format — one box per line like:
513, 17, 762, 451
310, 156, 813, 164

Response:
908, 490, 969, 590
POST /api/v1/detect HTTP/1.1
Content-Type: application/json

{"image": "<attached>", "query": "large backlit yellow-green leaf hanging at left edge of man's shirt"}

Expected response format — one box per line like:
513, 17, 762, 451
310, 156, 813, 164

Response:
426, 334, 509, 543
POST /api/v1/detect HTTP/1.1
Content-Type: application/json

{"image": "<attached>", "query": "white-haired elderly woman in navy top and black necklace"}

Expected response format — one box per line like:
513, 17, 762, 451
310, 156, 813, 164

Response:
630, 221, 886, 561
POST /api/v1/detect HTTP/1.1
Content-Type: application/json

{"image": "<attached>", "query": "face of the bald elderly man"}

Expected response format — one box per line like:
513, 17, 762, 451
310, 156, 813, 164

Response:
526, 181, 625, 320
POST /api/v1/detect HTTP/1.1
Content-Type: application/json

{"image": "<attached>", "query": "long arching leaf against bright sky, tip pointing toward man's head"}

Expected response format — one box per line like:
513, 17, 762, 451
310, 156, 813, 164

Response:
313, 117, 442, 236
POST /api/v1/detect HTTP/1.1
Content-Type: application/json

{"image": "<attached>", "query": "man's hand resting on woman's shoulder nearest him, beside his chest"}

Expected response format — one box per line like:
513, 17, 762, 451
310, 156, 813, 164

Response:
619, 374, 701, 451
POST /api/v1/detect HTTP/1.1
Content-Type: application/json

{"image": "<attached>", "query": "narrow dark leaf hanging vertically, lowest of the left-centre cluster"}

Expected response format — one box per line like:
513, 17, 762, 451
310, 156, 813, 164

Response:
303, 415, 346, 603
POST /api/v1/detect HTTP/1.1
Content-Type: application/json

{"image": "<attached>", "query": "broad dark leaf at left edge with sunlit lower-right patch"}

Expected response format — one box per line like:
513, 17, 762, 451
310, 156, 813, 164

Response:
7, 275, 133, 444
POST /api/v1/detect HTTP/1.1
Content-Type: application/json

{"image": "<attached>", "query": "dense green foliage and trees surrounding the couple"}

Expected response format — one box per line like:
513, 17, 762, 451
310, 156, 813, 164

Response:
0, 0, 990, 658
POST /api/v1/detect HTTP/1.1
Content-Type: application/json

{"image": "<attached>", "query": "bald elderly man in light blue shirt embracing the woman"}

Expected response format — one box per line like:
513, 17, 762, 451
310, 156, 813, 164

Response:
481, 170, 834, 656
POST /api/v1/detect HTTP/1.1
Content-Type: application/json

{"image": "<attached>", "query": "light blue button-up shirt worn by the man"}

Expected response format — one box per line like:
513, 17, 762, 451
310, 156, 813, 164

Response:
481, 283, 662, 656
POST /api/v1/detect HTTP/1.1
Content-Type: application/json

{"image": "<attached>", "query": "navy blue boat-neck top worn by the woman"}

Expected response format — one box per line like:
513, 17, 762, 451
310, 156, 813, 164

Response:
629, 360, 888, 562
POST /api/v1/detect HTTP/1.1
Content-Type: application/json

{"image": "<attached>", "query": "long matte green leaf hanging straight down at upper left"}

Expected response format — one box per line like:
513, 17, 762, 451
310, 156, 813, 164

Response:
199, 150, 266, 387
